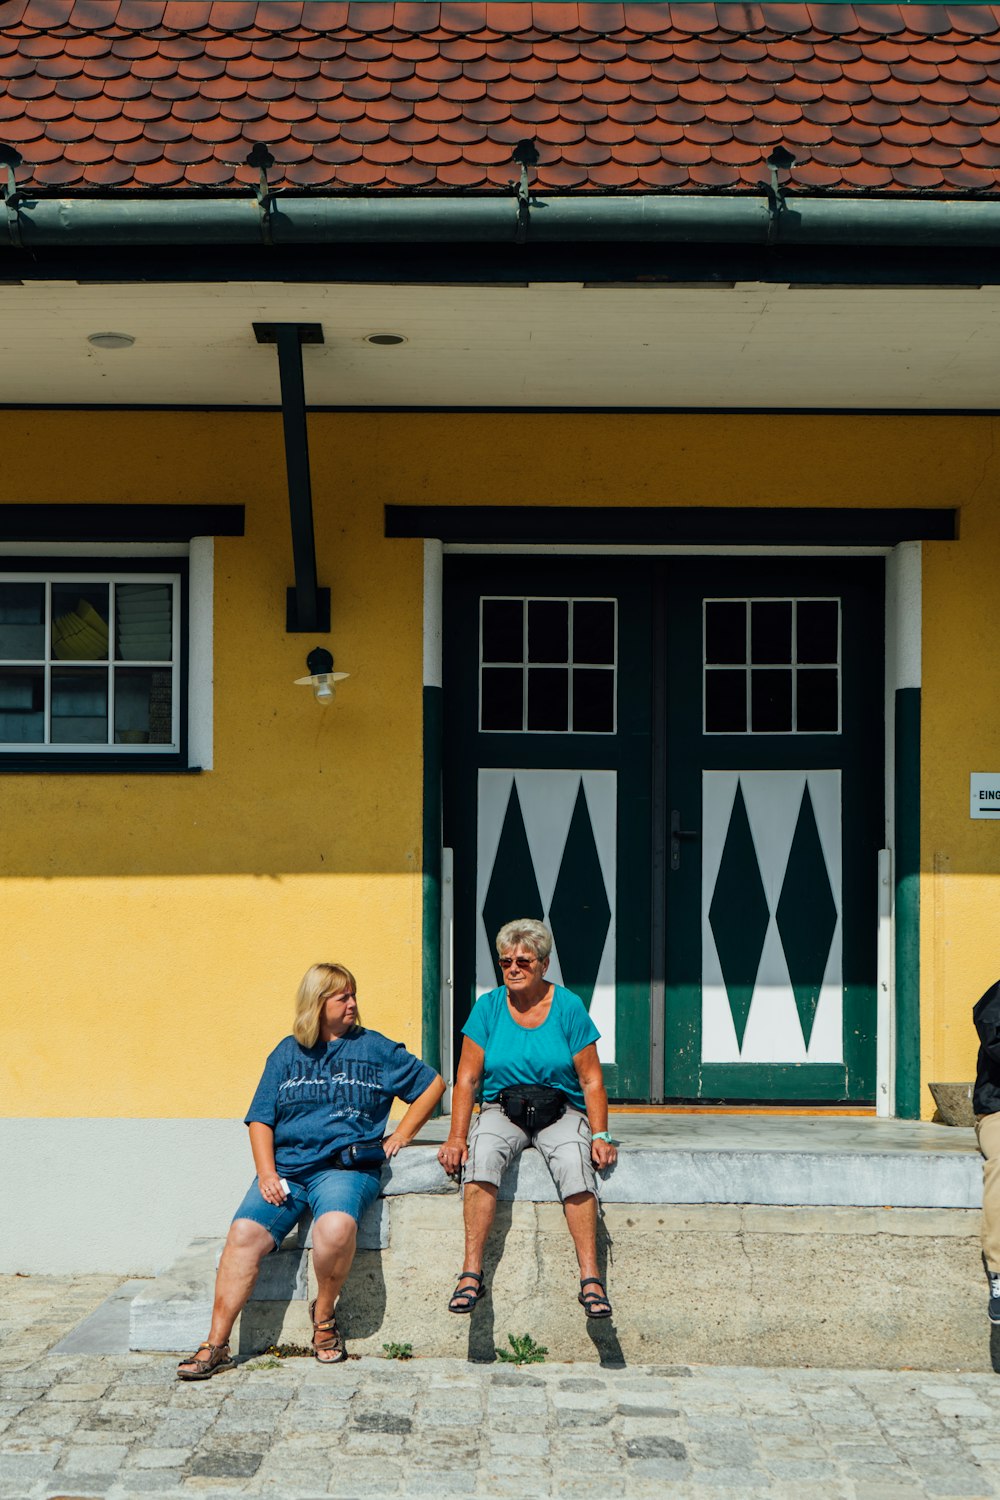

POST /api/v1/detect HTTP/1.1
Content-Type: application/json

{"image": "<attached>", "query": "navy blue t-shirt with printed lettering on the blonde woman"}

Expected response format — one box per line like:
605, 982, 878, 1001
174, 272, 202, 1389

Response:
246, 1026, 436, 1178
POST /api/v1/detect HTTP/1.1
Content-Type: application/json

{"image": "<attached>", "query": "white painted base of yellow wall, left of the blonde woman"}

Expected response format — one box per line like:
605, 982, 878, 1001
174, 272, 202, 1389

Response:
0, 1119, 253, 1277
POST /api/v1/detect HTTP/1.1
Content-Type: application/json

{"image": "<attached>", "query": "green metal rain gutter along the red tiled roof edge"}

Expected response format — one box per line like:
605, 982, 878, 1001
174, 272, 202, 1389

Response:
0, 192, 1000, 251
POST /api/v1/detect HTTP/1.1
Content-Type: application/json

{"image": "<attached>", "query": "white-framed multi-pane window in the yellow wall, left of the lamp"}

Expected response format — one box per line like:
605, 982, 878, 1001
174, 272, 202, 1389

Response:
0, 569, 181, 756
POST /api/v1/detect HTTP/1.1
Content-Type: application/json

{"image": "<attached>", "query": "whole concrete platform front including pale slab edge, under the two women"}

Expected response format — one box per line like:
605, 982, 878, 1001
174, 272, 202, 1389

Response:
129, 1116, 990, 1370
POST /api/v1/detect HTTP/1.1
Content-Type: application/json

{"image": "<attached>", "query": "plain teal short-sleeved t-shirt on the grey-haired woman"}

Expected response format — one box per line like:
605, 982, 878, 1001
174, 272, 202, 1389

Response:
462, 984, 601, 1110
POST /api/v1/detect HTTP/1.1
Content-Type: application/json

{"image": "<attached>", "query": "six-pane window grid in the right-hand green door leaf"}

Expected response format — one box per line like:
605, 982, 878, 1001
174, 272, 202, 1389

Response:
702, 596, 841, 735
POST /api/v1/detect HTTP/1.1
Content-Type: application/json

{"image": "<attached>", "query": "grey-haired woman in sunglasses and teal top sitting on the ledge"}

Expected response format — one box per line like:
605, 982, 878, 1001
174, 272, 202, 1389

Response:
438, 918, 618, 1317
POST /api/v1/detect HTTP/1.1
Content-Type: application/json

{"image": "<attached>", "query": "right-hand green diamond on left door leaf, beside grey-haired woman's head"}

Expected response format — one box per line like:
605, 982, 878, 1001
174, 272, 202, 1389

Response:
549, 782, 612, 1008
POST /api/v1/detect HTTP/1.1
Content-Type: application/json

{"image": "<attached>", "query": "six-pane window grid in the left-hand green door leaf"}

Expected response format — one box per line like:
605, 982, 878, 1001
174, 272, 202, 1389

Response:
480, 594, 618, 735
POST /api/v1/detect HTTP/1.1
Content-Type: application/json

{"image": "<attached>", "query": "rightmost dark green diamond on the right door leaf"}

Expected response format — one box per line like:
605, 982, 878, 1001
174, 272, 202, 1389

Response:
775, 782, 837, 1047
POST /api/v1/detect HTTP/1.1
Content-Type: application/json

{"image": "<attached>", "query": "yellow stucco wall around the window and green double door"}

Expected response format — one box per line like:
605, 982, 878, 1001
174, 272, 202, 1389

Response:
0, 411, 1000, 1116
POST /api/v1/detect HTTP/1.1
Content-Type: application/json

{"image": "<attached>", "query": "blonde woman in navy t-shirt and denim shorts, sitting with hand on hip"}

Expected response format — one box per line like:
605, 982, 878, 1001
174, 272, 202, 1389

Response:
177, 963, 444, 1380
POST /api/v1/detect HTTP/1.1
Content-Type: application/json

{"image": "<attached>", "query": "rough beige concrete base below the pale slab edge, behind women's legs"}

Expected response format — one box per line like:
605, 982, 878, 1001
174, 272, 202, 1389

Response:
130, 1194, 991, 1370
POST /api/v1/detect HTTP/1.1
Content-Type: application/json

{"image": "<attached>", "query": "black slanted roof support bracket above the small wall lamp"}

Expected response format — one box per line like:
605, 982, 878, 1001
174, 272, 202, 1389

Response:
253, 322, 330, 635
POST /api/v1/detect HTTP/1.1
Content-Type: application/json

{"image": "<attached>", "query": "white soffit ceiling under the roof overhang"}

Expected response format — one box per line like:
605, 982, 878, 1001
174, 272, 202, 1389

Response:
0, 282, 1000, 408
